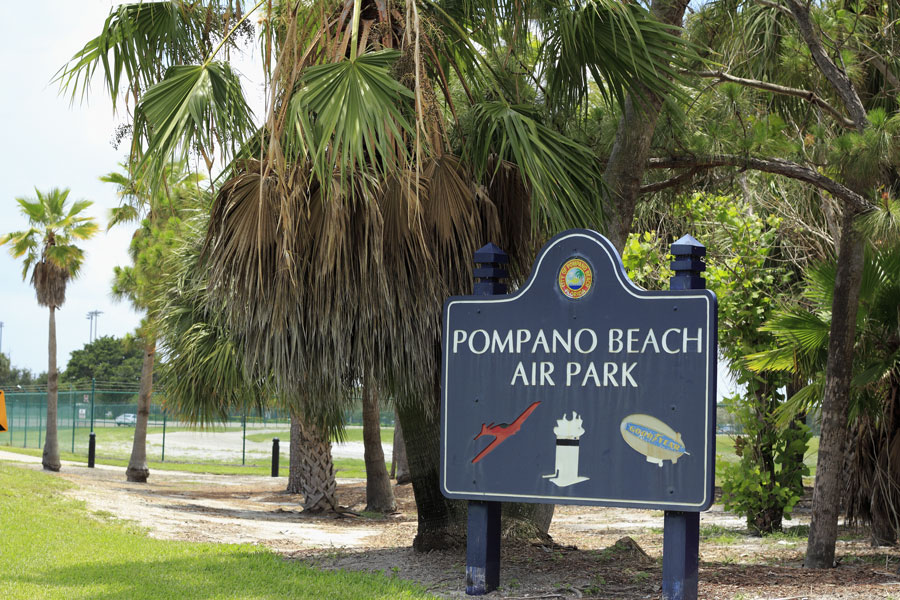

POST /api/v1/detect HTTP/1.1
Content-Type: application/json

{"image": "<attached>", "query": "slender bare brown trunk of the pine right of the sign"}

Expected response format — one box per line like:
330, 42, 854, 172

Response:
804, 209, 864, 569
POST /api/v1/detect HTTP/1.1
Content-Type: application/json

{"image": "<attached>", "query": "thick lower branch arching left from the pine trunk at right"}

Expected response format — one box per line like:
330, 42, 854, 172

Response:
647, 154, 875, 212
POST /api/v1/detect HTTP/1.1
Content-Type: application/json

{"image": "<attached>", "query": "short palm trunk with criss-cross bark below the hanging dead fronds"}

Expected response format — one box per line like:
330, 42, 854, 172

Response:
287, 412, 338, 512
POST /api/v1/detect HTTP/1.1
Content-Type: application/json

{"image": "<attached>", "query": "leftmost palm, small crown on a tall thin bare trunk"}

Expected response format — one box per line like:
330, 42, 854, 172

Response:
0, 188, 97, 471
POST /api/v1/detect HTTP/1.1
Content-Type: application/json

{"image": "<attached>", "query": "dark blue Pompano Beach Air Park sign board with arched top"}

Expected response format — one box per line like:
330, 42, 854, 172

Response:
441, 230, 717, 512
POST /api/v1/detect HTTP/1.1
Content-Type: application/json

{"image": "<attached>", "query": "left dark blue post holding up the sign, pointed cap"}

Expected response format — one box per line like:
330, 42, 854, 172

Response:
466, 244, 509, 596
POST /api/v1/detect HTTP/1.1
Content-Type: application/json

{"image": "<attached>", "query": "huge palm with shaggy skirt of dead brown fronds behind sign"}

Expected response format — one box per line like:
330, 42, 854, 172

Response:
61, 0, 683, 547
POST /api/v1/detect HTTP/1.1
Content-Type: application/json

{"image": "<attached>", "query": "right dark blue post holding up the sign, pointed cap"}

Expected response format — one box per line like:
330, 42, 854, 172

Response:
662, 235, 706, 600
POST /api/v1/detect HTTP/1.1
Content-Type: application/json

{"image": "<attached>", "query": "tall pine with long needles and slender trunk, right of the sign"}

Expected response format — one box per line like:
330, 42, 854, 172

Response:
600, 0, 900, 568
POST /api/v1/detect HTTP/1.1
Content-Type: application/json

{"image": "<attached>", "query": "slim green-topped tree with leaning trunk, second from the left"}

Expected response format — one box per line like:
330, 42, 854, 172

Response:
100, 164, 201, 483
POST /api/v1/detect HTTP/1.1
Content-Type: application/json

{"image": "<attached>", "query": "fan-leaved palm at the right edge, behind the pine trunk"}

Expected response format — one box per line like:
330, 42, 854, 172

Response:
750, 202, 900, 544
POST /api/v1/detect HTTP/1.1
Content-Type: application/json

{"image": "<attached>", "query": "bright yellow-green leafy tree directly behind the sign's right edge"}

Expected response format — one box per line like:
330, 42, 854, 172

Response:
623, 194, 809, 534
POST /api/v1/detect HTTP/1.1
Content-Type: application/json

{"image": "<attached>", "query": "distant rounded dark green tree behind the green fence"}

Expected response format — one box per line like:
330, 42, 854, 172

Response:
60, 335, 142, 386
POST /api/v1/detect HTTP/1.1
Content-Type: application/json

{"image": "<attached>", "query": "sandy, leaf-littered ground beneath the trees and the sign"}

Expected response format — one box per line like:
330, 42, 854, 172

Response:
0, 452, 900, 600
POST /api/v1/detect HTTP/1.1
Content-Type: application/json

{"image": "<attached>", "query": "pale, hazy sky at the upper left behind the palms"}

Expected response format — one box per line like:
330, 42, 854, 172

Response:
0, 0, 261, 373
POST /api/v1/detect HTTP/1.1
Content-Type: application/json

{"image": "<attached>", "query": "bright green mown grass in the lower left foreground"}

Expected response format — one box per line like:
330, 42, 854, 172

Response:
0, 463, 433, 600
